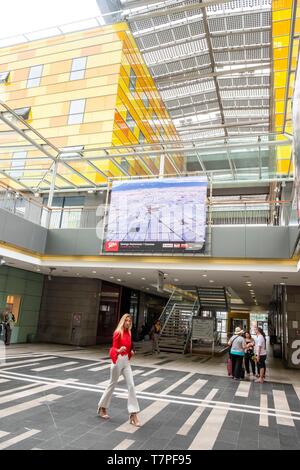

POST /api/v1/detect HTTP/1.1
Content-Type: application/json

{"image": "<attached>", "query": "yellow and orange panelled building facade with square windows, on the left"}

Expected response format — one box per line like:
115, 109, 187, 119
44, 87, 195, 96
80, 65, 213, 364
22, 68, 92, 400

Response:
0, 23, 182, 187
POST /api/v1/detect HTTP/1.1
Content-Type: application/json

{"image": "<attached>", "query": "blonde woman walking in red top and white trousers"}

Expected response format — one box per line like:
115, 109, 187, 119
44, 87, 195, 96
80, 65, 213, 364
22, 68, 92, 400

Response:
98, 313, 140, 426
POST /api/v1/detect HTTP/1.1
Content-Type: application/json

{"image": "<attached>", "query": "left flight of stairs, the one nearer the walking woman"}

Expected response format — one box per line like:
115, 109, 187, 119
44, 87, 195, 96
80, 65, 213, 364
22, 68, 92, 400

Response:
159, 302, 198, 354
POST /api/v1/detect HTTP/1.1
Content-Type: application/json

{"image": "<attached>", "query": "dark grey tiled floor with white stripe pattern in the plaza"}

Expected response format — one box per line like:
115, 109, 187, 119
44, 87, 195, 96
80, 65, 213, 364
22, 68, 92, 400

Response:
0, 343, 300, 450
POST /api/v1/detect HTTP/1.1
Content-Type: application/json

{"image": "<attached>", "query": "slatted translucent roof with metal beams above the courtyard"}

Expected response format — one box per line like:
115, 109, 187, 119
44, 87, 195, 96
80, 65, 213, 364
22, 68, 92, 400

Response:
122, 0, 272, 139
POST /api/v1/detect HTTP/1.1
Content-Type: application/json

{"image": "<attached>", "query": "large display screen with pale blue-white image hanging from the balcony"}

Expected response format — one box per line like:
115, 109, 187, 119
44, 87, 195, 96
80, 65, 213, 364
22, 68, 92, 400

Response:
104, 177, 207, 253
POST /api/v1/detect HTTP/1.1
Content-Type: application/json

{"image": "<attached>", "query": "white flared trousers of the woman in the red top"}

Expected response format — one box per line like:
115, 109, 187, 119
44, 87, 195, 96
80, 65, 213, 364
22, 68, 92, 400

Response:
98, 355, 140, 414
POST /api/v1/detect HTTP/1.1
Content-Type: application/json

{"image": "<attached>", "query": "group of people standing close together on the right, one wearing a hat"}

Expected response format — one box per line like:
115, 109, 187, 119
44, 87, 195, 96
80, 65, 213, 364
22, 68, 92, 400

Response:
228, 327, 267, 383
